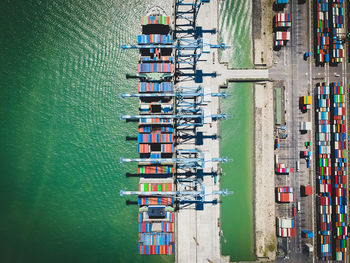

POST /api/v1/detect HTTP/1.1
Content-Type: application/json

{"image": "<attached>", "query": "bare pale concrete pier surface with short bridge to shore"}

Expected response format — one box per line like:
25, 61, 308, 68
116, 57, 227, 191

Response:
175, 0, 268, 262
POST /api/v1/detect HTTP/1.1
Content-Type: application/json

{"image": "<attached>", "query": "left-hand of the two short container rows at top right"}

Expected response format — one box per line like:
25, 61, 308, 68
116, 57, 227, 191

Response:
315, 0, 329, 63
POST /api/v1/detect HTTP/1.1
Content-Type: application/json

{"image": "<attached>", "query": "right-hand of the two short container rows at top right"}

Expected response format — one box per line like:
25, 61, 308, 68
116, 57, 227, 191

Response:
330, 0, 344, 63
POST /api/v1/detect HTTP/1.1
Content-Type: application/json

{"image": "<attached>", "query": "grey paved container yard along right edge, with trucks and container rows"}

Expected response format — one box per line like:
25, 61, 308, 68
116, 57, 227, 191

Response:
269, 0, 349, 262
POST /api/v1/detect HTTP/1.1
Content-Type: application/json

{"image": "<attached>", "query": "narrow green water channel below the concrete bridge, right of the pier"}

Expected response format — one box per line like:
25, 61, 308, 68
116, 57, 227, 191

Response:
220, 83, 254, 261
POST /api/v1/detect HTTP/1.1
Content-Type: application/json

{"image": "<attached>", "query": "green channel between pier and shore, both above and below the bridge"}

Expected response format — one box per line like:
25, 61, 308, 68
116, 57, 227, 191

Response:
220, 0, 255, 261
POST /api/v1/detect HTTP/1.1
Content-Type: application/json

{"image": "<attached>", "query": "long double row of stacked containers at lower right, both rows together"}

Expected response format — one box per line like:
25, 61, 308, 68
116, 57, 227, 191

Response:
315, 82, 347, 261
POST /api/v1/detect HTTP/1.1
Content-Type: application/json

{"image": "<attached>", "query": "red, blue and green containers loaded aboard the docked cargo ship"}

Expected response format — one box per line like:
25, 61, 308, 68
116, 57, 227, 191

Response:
137, 15, 175, 255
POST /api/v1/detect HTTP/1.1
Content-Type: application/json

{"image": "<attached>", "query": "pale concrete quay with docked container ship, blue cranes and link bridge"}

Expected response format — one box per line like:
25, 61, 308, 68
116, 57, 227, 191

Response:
120, 0, 269, 262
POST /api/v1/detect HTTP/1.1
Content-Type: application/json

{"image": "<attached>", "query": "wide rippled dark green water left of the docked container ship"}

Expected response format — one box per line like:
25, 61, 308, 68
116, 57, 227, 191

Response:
0, 0, 173, 263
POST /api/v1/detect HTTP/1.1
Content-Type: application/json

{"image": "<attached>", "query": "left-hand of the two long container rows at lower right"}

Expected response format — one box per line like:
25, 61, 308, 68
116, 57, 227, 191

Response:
315, 83, 332, 260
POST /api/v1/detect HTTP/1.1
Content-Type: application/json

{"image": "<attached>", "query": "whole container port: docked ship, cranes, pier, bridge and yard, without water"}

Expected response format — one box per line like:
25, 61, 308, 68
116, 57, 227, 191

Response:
117, 0, 349, 262
